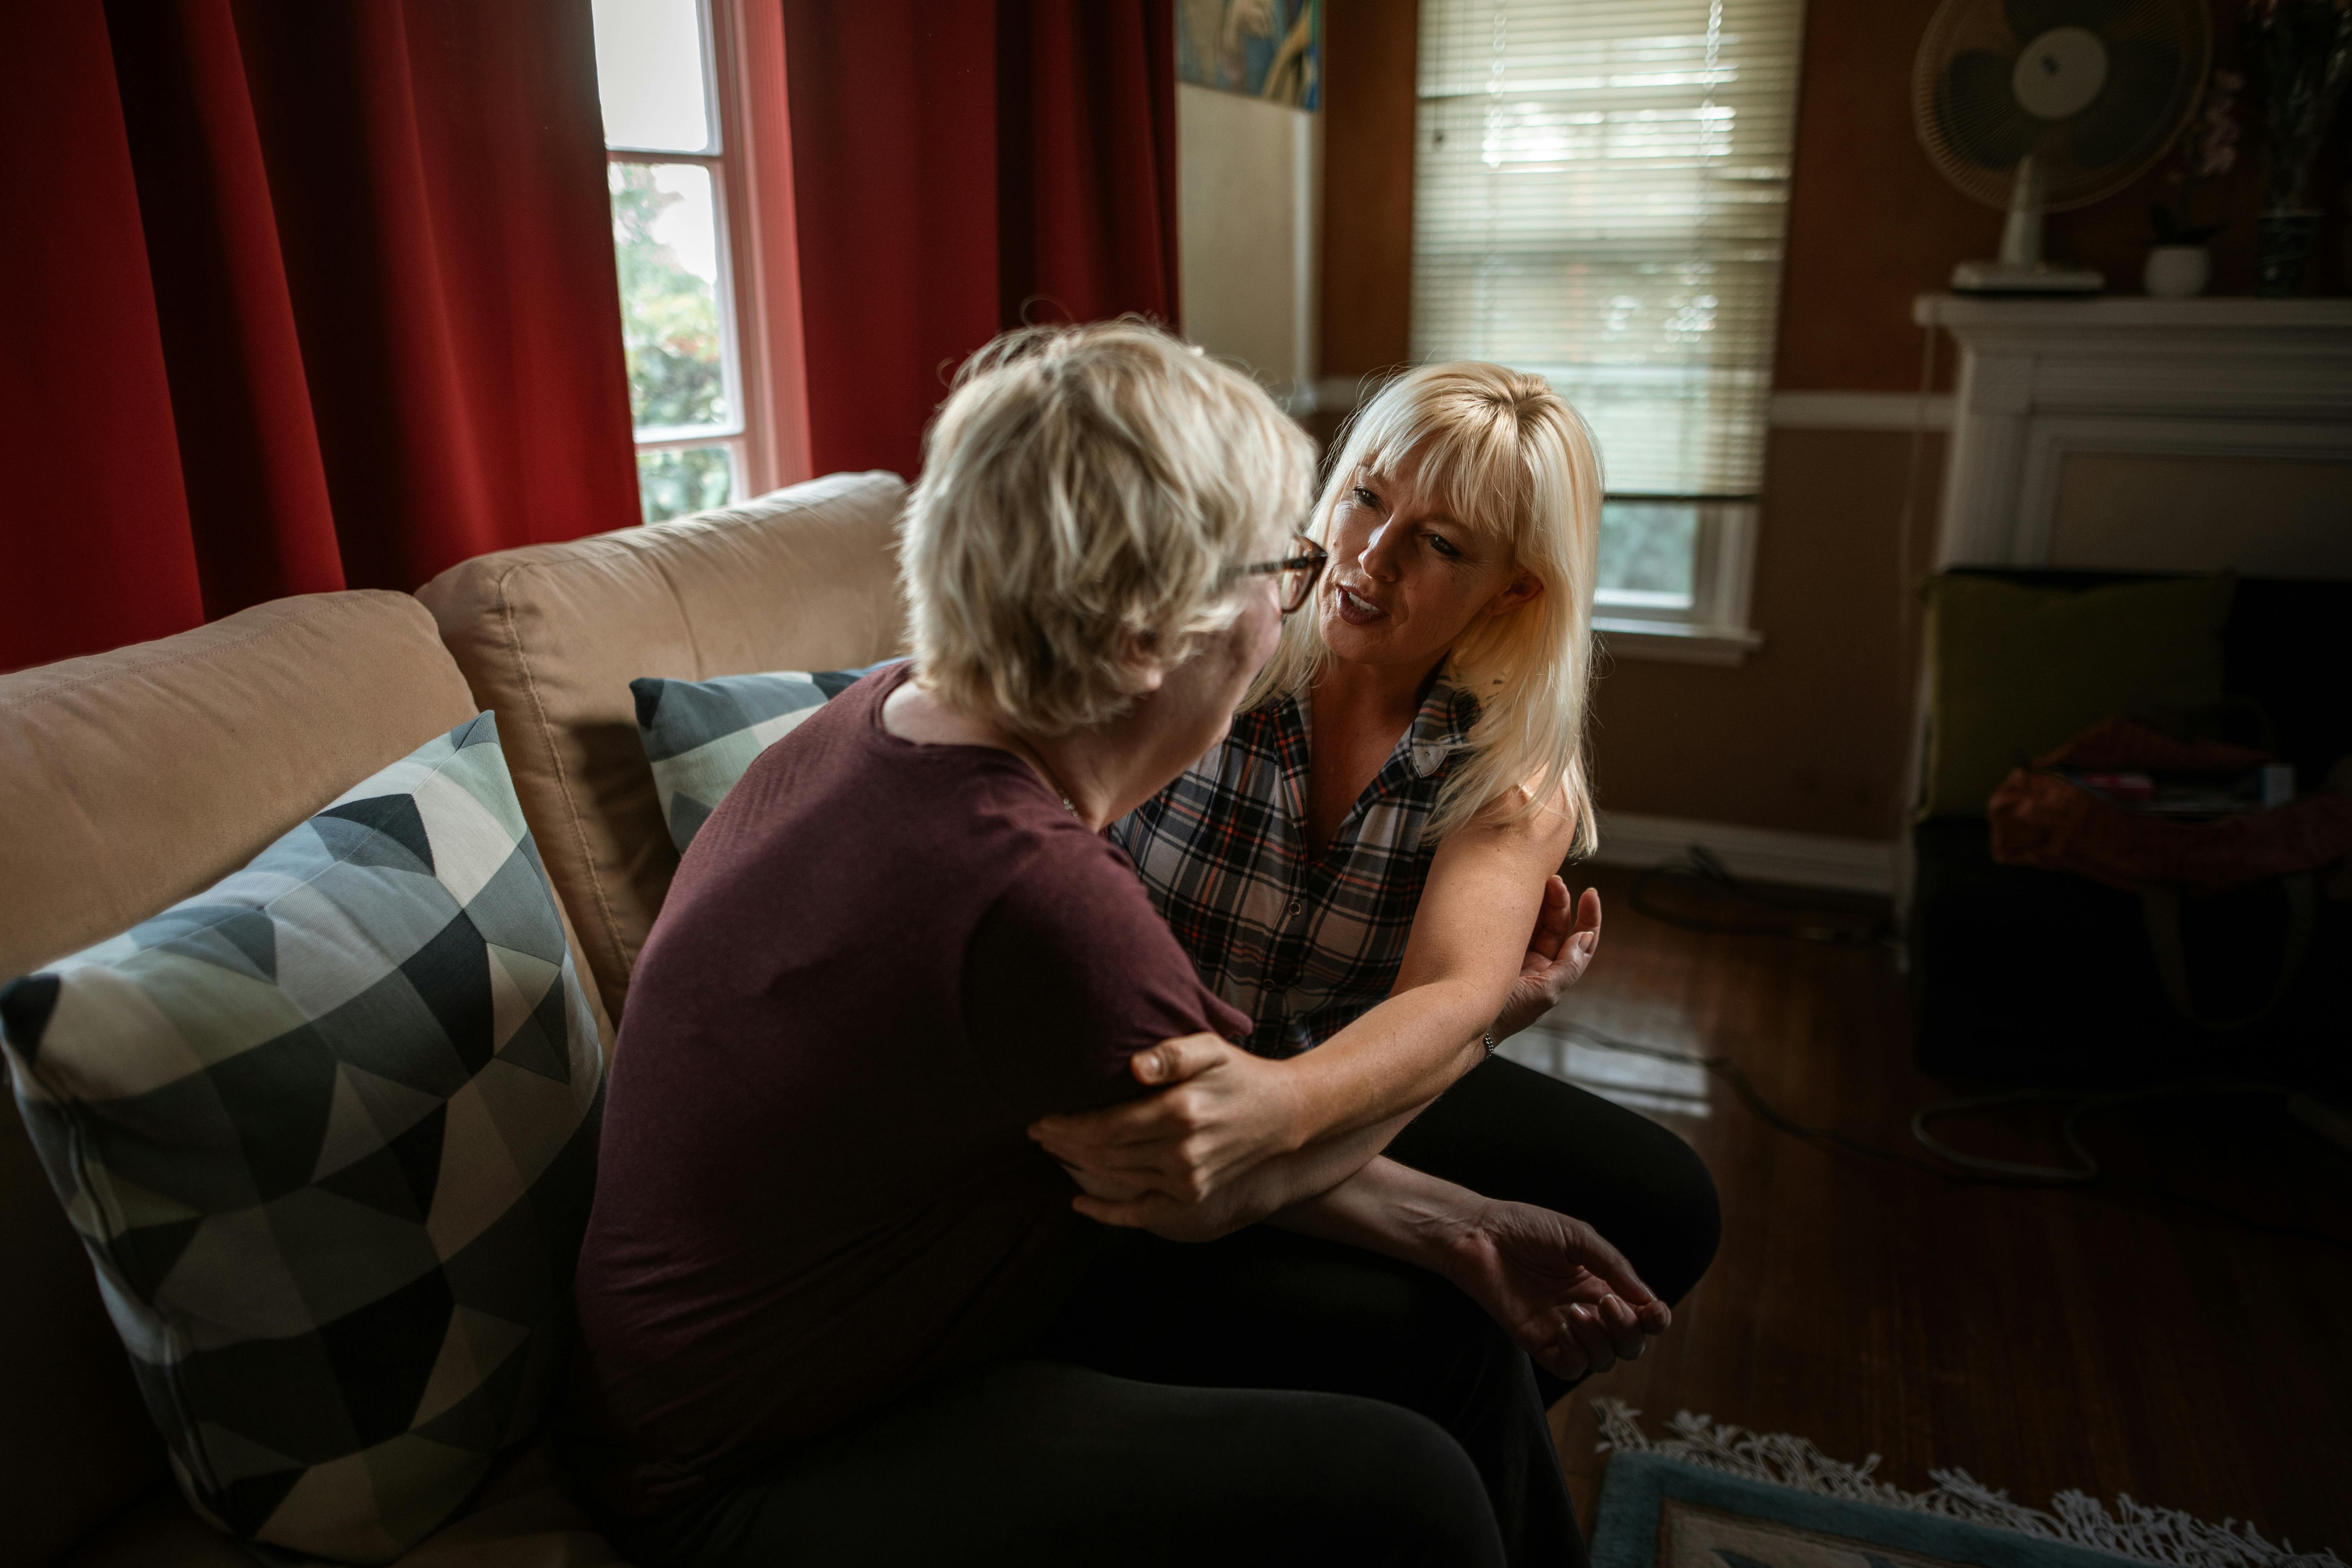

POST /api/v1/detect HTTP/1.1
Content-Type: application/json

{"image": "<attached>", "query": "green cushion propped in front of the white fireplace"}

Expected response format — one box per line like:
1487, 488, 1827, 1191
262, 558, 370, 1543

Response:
1919, 573, 2237, 818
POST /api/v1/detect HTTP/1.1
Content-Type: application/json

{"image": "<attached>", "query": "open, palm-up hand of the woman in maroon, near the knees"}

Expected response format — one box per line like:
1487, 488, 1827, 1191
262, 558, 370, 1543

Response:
1444, 1201, 1675, 1377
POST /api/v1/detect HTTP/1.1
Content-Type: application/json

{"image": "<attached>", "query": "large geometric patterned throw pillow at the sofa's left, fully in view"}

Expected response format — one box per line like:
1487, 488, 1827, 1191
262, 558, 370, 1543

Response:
0, 712, 604, 1563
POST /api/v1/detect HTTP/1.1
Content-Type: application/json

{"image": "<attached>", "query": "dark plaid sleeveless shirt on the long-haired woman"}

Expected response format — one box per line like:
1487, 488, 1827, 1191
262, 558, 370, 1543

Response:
1110, 675, 1477, 1056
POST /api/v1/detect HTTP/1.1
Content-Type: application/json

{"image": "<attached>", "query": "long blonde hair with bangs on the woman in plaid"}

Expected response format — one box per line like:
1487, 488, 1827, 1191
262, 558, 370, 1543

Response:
1242, 362, 1602, 856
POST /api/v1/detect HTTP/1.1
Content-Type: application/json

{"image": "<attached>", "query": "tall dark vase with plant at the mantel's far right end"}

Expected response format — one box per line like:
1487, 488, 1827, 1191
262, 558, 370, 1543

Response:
2239, 0, 2352, 296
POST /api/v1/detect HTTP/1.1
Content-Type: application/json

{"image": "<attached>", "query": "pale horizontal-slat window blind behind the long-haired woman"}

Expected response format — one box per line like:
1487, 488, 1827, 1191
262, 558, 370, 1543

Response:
1414, 0, 1804, 498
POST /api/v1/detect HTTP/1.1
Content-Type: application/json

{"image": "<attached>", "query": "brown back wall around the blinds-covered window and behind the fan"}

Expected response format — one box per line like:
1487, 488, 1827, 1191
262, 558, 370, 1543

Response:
1322, 0, 2340, 837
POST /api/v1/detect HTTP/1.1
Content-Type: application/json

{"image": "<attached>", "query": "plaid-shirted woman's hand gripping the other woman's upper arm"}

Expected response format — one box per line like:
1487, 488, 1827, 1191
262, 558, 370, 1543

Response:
1028, 1034, 1305, 1234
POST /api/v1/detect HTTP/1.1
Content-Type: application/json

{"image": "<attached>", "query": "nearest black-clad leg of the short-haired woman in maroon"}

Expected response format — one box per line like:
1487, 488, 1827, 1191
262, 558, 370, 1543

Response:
604, 1361, 1503, 1568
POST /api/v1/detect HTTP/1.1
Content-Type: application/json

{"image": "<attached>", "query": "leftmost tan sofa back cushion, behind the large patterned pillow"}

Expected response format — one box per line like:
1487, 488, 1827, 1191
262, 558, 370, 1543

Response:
0, 593, 607, 1563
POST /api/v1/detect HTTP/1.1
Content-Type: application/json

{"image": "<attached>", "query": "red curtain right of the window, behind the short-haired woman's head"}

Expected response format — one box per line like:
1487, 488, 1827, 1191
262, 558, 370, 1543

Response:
783, 0, 1178, 475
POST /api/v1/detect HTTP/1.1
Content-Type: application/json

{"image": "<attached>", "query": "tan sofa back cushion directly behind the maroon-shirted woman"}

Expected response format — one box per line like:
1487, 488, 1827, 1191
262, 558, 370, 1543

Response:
416, 473, 906, 1018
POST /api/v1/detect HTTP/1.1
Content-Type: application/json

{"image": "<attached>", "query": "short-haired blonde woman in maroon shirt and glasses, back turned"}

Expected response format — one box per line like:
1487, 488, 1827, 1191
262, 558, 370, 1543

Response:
569, 324, 1663, 1568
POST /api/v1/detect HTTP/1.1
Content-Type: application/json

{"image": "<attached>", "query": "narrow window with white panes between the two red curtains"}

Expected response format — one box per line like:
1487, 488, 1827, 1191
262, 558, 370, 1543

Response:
593, 0, 804, 522
